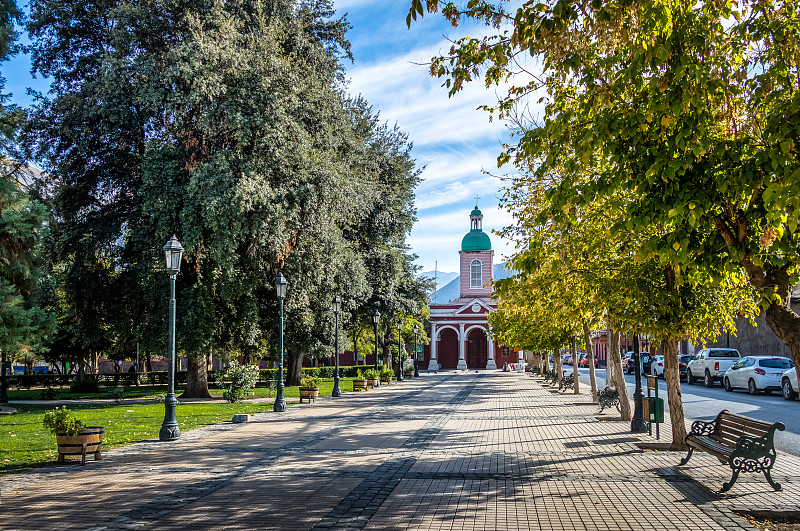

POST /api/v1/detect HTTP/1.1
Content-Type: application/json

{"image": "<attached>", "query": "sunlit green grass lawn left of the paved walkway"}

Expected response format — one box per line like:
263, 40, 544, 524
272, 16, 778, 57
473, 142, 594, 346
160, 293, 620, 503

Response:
0, 378, 362, 474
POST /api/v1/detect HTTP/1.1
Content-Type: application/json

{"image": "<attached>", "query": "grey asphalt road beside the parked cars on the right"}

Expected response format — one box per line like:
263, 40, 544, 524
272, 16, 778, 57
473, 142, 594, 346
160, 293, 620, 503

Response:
564, 366, 800, 456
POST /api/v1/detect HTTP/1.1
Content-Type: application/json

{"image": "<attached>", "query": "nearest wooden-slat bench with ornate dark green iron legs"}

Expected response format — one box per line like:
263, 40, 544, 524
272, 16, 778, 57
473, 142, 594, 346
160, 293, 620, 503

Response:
680, 409, 786, 492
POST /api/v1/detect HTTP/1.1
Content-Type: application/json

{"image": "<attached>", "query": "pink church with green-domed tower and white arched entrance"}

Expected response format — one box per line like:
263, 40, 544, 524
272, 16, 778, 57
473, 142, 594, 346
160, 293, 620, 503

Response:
424, 205, 523, 371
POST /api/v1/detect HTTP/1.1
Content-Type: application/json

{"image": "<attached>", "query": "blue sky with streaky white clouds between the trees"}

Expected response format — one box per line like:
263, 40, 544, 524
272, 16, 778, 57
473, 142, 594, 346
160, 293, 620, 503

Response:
7, 0, 513, 272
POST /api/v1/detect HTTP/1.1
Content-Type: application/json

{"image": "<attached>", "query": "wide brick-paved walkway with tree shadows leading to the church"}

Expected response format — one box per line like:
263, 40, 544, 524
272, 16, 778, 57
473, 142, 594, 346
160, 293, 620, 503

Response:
0, 372, 800, 530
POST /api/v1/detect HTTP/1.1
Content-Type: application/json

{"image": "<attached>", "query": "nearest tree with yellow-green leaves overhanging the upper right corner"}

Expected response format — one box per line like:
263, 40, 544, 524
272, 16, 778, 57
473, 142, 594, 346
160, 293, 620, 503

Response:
408, 0, 800, 402
